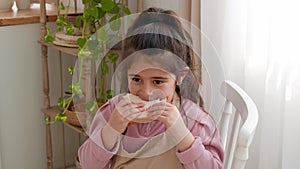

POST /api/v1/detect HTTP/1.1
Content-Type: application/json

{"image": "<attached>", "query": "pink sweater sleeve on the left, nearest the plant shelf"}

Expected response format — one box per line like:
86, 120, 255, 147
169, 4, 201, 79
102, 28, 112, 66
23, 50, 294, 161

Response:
78, 99, 120, 169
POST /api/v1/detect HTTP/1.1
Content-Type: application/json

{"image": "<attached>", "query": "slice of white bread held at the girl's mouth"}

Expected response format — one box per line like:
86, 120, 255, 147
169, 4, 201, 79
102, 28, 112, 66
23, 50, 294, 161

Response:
127, 94, 166, 123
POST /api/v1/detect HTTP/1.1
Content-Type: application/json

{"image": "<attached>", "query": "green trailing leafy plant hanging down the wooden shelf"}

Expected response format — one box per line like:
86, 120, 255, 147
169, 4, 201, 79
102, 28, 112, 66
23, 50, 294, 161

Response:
44, 0, 130, 124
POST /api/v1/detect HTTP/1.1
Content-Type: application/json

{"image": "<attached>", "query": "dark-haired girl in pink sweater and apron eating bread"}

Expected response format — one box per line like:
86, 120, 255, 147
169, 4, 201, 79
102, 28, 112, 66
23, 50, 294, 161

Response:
78, 8, 224, 169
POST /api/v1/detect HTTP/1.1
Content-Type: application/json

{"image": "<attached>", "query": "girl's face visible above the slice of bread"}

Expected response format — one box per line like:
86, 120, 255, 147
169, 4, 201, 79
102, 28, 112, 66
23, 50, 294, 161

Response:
127, 61, 176, 101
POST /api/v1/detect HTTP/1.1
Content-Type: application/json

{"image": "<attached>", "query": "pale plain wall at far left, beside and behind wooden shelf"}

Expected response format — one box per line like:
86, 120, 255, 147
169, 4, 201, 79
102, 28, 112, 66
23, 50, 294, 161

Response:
0, 24, 78, 169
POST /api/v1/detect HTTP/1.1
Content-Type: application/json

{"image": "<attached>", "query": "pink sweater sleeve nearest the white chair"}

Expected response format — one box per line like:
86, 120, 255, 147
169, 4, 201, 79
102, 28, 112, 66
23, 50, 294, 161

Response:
176, 111, 224, 169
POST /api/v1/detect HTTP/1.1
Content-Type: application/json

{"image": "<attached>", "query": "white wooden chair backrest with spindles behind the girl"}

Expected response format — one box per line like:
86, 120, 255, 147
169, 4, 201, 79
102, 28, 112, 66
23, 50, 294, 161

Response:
218, 81, 258, 169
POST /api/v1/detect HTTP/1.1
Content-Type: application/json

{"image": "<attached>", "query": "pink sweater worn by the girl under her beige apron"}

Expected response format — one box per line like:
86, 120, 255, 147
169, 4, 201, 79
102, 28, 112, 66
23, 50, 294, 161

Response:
78, 96, 224, 169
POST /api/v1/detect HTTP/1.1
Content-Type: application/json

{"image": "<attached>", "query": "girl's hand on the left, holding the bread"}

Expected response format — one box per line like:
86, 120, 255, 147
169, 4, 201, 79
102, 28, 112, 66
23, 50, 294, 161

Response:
108, 96, 144, 133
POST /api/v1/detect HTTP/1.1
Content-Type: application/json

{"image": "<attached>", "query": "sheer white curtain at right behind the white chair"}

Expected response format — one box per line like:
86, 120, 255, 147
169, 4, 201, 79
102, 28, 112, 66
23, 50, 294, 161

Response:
210, 0, 300, 169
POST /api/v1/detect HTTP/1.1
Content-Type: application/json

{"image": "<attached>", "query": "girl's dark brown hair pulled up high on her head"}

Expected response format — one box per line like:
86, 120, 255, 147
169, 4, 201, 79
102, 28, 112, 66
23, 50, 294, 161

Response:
118, 8, 203, 106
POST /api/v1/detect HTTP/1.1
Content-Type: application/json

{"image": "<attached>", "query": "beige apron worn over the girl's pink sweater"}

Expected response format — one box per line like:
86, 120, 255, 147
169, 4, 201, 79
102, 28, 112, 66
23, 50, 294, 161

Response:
110, 132, 182, 169
